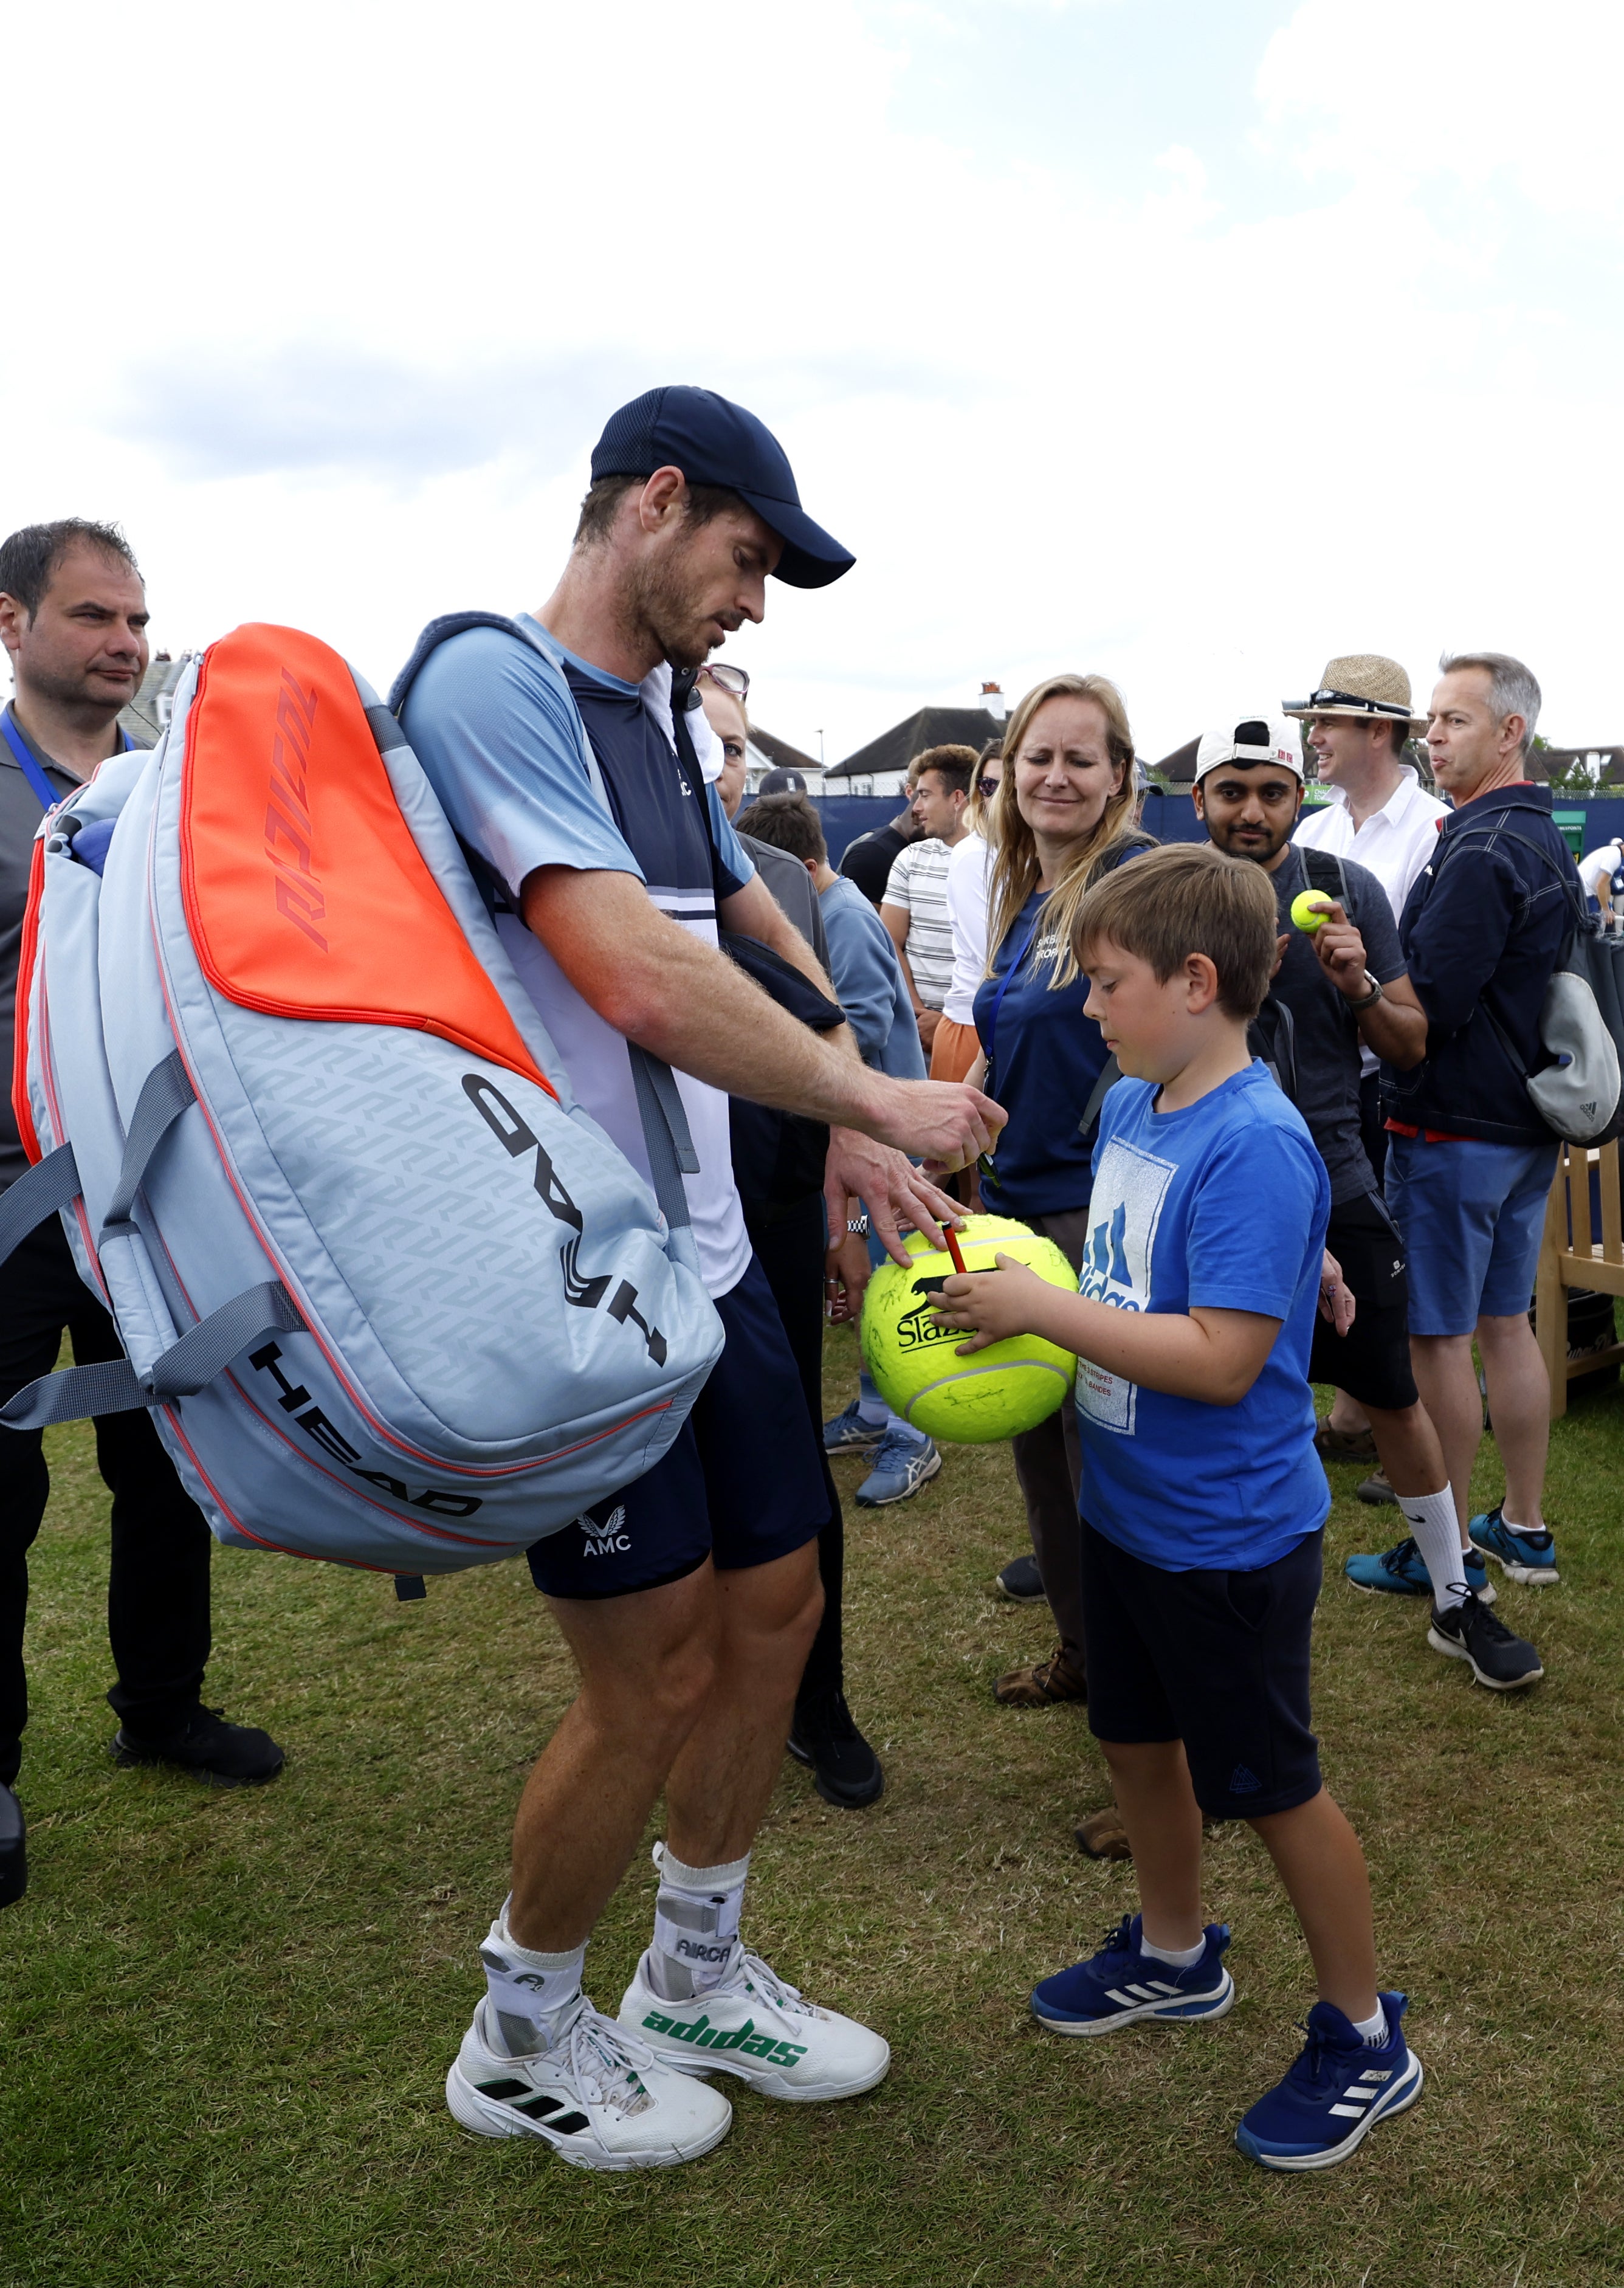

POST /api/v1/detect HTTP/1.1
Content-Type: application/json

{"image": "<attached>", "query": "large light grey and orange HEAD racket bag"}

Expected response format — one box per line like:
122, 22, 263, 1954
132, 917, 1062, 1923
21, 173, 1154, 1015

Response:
0, 627, 720, 1574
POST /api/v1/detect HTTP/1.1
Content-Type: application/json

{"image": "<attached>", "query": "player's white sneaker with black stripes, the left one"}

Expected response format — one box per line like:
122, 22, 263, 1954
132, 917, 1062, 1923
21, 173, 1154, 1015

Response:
446, 1997, 732, 2169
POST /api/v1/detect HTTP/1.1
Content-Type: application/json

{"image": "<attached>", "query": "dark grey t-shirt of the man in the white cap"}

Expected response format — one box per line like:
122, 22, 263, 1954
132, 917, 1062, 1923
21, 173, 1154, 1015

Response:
1270, 844, 1406, 1208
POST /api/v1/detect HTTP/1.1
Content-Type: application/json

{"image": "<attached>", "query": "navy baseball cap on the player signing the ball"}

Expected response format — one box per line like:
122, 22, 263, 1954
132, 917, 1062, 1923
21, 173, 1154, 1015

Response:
593, 387, 858, 588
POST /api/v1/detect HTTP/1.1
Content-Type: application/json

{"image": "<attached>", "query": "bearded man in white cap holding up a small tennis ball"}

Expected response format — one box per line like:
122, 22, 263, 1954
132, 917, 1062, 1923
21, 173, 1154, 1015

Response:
1194, 716, 1544, 1691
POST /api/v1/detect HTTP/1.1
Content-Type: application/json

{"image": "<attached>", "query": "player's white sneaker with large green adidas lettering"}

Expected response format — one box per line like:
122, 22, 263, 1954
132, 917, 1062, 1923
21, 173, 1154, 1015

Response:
620, 1947, 892, 2105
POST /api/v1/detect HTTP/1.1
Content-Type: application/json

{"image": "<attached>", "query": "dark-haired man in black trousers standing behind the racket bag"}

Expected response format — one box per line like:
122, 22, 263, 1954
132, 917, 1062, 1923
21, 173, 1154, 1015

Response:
0, 519, 281, 1906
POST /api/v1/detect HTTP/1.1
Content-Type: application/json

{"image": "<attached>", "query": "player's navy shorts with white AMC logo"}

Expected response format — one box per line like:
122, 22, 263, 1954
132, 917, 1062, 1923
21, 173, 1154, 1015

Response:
526, 1256, 828, 1597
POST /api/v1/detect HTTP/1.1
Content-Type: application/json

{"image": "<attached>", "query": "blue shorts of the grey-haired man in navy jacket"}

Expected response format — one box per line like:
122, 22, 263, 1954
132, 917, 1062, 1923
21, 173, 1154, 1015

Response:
1386, 1135, 1558, 1334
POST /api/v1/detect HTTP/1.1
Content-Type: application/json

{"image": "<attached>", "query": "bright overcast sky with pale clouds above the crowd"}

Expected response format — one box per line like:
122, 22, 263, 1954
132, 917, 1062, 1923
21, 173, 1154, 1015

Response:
0, 0, 1624, 762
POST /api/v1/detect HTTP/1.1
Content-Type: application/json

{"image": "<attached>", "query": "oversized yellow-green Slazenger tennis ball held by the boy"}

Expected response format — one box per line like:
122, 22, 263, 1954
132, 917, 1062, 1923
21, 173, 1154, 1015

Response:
862, 1215, 1078, 1446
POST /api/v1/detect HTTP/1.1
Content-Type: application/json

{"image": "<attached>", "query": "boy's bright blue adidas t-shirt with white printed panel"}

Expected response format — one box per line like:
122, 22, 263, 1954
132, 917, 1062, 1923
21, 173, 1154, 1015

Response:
1078, 1061, 1331, 1572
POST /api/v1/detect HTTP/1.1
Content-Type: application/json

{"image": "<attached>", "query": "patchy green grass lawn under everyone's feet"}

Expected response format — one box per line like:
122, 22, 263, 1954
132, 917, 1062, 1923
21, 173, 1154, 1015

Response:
0, 1339, 1624, 2288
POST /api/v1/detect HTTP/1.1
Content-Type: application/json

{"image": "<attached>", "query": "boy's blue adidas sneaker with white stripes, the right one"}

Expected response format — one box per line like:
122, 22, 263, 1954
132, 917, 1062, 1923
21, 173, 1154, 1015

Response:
1235, 1995, 1425, 2169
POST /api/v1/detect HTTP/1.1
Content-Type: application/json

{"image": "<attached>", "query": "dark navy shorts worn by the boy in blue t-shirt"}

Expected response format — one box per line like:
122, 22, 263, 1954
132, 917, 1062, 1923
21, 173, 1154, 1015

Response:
1082, 1517, 1324, 1819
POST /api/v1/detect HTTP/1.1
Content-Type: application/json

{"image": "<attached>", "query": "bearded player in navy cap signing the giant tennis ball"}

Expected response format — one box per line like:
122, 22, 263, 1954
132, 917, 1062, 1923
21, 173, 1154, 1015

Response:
396, 389, 1002, 2169
